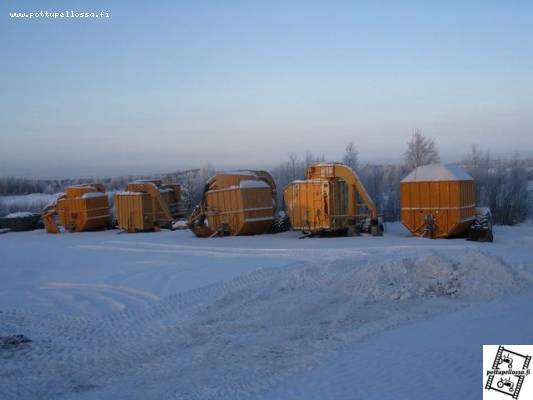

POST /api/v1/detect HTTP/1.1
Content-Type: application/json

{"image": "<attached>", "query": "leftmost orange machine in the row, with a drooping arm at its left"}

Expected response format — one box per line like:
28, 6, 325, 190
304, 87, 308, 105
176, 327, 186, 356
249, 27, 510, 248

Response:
42, 183, 111, 233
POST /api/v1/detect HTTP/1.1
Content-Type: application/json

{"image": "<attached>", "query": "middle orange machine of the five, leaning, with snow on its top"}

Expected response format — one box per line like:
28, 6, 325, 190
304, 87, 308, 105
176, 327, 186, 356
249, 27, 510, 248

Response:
188, 171, 276, 237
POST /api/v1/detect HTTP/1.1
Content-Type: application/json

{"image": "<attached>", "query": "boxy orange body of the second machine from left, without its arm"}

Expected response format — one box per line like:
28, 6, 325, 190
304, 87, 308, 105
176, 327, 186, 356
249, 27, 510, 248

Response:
115, 192, 155, 232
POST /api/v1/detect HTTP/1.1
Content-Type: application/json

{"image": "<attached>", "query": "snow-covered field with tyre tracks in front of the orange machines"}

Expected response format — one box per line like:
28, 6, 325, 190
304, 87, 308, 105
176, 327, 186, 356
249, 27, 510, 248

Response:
0, 224, 533, 400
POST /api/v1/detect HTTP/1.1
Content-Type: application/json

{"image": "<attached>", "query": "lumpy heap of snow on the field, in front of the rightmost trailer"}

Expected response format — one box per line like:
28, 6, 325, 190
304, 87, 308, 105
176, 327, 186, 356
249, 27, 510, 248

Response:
340, 251, 520, 301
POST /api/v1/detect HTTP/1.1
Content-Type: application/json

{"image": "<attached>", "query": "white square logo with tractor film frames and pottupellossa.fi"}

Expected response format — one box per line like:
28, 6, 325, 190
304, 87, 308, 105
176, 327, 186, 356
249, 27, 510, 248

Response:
483, 345, 533, 400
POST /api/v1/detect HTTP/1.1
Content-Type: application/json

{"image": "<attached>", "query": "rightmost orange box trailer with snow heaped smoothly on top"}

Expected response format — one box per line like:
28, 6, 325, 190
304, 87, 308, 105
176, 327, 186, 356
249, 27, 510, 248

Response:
400, 164, 476, 238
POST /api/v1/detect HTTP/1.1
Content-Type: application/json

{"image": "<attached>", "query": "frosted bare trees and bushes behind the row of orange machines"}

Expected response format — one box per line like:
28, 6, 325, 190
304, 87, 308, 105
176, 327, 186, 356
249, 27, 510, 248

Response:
0, 131, 533, 225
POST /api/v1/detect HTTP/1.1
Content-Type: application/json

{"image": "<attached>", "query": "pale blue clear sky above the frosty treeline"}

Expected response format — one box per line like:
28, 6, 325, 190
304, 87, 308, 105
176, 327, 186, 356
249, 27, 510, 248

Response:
0, 0, 533, 177
